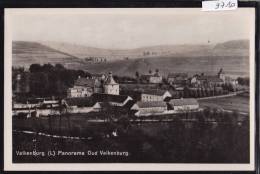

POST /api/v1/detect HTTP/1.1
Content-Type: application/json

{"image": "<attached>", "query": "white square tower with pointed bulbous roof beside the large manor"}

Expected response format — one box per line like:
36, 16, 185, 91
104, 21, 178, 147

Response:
104, 72, 119, 95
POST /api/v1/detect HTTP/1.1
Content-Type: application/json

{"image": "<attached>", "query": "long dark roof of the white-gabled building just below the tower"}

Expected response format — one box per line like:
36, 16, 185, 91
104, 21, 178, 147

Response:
91, 93, 132, 103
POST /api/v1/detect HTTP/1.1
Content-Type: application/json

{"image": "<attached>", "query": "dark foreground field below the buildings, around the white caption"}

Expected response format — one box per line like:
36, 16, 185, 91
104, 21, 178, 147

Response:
13, 121, 249, 163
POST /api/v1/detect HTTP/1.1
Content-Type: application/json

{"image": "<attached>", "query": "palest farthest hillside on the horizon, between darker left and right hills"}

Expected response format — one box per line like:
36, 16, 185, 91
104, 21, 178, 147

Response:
42, 42, 212, 61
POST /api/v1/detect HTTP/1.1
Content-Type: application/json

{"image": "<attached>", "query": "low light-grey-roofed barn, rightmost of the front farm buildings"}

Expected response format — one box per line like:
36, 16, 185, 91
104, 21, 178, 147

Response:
168, 98, 199, 111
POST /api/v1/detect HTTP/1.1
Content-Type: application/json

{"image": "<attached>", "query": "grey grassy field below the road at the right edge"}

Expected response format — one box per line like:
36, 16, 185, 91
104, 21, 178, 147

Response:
199, 95, 249, 113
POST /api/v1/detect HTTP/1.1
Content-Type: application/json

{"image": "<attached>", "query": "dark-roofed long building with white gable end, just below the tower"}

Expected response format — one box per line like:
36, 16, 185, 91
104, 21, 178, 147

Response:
91, 93, 133, 106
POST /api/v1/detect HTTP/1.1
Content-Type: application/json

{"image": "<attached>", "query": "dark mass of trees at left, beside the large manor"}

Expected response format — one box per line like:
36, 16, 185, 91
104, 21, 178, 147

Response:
12, 64, 91, 97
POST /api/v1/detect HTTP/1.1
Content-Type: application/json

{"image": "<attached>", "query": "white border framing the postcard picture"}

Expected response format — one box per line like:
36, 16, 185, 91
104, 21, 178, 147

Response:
4, 8, 255, 171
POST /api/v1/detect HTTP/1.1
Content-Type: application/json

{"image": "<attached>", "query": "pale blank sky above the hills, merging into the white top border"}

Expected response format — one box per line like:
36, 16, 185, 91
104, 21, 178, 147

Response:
6, 8, 254, 49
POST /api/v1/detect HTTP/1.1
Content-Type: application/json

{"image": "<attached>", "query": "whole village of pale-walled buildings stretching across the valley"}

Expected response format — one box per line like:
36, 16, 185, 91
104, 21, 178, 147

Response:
13, 68, 244, 117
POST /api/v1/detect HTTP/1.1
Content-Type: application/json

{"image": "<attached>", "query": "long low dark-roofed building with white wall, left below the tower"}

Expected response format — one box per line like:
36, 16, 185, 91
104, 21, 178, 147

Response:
63, 97, 101, 113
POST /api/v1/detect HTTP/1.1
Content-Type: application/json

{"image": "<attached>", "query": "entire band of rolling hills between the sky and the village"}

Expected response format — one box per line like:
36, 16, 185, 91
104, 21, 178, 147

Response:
13, 40, 249, 76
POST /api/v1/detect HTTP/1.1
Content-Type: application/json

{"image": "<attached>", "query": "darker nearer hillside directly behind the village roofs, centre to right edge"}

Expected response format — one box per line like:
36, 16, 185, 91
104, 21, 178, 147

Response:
80, 56, 249, 76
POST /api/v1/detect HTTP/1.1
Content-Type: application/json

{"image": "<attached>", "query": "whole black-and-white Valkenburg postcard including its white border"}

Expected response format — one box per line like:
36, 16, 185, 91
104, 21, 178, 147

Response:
4, 8, 255, 171
